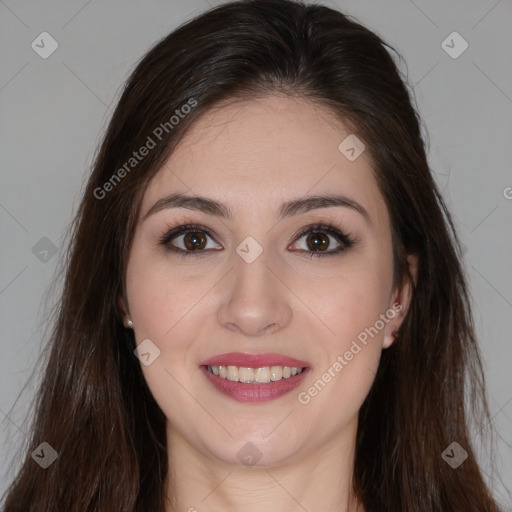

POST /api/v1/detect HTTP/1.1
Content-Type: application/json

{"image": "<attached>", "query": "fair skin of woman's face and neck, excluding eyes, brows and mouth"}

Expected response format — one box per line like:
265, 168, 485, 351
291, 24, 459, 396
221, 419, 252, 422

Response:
120, 96, 416, 512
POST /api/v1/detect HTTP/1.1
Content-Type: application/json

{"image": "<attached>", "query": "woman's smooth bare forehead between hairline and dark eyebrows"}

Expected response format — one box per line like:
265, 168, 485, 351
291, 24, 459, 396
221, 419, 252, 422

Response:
141, 96, 386, 226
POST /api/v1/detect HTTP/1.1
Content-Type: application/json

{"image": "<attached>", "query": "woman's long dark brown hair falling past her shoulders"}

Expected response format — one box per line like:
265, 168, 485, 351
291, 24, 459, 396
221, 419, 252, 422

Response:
0, 0, 504, 512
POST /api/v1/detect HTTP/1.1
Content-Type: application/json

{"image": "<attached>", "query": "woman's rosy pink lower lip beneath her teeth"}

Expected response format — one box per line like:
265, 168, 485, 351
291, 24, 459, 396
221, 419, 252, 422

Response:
201, 366, 309, 402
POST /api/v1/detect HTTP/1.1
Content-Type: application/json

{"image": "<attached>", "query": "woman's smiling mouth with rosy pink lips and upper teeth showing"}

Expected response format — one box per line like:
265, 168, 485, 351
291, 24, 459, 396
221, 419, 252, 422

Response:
200, 353, 311, 402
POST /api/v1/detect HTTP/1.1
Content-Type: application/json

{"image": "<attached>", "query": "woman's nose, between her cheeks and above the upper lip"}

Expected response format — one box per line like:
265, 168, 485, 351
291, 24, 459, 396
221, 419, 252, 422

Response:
217, 247, 292, 337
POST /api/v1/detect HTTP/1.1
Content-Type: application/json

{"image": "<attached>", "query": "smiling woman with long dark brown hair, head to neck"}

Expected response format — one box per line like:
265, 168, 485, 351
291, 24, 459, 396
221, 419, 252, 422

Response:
0, 0, 504, 512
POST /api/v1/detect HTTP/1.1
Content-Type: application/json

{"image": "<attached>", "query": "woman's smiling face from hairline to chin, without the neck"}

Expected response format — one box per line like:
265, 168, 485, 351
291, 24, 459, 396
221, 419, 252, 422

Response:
121, 96, 409, 465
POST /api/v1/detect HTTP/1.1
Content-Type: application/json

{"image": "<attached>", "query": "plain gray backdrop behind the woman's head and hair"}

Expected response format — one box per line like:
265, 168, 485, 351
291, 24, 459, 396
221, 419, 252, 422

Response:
0, 0, 512, 503
